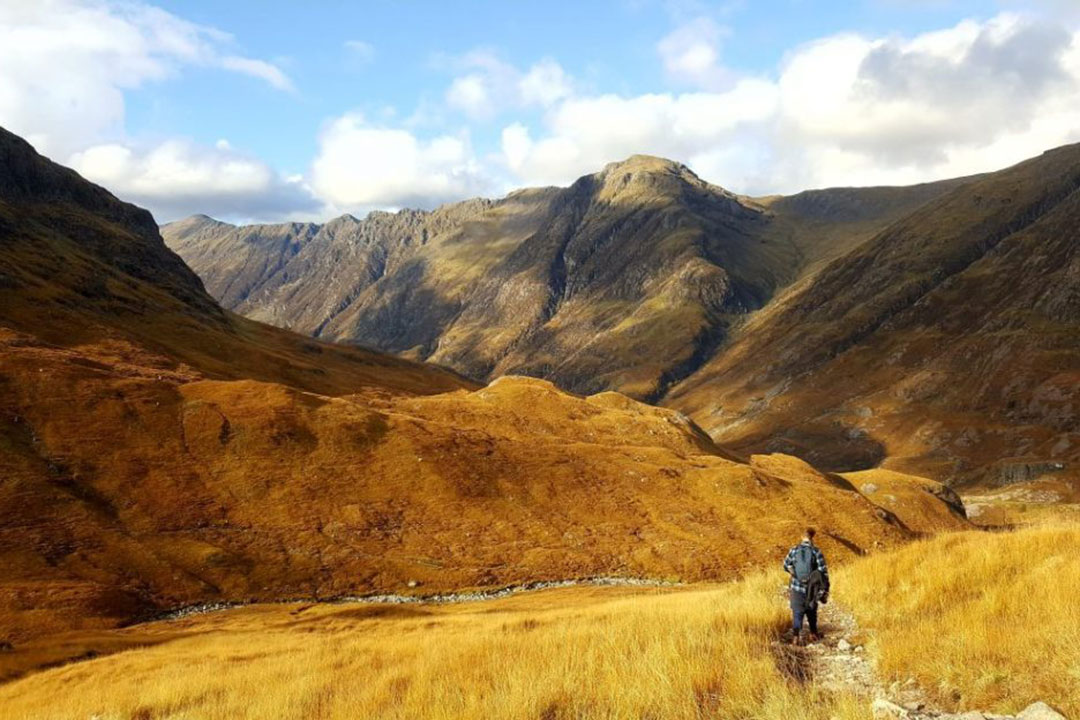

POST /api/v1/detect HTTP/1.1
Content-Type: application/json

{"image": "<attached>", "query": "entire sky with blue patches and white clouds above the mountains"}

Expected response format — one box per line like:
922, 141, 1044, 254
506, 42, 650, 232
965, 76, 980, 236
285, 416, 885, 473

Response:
0, 0, 1080, 222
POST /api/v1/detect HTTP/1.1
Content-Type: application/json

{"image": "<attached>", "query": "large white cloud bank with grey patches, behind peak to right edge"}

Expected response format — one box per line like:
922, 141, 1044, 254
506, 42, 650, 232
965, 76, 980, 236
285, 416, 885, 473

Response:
501, 13, 1080, 193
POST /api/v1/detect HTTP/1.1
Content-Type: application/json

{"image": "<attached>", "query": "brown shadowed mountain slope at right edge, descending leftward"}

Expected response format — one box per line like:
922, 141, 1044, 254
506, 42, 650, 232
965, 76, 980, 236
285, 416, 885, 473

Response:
666, 146, 1080, 483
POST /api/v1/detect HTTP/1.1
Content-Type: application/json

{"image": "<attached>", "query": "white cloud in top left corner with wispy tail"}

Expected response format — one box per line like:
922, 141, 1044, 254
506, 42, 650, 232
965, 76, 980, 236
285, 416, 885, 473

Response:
0, 0, 291, 159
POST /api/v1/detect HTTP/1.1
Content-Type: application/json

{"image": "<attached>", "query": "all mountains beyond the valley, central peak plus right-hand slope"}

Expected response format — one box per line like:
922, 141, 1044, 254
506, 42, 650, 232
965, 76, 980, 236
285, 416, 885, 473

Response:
162, 152, 1080, 490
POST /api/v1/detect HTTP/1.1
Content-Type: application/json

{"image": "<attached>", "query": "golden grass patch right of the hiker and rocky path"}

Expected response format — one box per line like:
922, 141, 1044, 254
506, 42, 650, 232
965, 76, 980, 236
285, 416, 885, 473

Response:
836, 524, 1080, 717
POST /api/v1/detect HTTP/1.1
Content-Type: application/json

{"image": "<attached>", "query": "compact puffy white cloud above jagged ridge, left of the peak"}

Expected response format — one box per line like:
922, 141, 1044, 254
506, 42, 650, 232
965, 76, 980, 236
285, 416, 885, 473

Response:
311, 113, 491, 212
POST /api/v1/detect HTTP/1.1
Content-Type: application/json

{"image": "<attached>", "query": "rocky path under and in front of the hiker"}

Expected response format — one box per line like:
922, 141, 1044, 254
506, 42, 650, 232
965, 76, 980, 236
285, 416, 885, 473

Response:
773, 597, 1067, 720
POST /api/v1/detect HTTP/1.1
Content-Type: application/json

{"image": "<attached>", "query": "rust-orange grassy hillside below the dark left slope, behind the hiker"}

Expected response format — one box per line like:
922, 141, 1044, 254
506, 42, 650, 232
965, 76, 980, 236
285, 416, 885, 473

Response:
0, 341, 966, 646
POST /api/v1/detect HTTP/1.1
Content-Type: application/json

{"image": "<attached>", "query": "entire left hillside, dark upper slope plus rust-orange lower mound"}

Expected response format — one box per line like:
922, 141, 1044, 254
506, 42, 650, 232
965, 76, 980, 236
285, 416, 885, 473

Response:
0, 125, 966, 674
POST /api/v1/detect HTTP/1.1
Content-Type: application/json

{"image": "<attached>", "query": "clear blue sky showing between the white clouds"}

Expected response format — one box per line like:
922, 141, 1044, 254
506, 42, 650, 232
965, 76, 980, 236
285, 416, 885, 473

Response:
137, 0, 1000, 173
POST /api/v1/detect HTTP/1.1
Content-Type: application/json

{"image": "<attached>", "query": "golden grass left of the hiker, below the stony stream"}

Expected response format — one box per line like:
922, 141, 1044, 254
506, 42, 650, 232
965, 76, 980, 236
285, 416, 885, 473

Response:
0, 575, 865, 720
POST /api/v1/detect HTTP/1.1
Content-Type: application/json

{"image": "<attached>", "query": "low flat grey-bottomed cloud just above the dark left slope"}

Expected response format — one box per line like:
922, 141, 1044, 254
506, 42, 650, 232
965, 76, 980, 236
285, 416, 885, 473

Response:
70, 139, 320, 222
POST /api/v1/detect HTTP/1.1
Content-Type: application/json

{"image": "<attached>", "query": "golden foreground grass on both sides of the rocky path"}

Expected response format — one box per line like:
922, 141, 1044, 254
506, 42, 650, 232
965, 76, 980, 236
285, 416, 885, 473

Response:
0, 524, 1080, 720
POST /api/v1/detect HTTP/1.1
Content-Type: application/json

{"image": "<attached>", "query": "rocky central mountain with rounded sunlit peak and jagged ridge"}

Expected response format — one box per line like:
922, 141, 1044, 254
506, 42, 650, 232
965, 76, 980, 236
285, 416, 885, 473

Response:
162, 155, 948, 398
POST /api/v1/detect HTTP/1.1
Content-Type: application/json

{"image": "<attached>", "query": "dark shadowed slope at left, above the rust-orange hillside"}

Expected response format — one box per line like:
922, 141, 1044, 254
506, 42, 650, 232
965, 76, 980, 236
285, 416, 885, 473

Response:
0, 128, 469, 394
